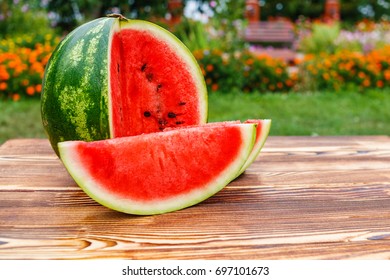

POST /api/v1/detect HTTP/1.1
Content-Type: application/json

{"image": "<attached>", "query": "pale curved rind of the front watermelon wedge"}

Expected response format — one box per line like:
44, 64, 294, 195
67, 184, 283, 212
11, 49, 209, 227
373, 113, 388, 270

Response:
58, 124, 256, 215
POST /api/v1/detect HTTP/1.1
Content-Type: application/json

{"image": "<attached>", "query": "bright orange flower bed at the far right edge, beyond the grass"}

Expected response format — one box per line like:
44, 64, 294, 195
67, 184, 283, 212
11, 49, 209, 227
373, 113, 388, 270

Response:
299, 46, 390, 91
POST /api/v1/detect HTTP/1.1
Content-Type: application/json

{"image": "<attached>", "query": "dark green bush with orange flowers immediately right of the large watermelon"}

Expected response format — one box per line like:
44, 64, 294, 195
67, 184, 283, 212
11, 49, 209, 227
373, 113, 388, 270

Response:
194, 50, 296, 92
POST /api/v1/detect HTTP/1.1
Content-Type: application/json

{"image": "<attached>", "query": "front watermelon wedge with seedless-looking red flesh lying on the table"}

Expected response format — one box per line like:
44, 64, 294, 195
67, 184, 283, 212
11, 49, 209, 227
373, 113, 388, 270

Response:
58, 123, 257, 215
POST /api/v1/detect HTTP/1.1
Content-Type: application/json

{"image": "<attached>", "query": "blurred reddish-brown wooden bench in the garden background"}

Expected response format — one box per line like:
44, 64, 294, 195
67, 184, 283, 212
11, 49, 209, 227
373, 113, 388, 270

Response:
244, 21, 295, 46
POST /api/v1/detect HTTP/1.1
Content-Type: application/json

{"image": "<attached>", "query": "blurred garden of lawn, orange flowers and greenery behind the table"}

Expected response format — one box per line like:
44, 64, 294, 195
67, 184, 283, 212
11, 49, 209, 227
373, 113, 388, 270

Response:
0, 0, 390, 144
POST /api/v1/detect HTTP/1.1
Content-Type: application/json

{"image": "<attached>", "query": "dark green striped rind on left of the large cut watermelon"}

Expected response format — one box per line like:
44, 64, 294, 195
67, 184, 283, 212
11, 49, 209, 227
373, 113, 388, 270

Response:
41, 18, 115, 154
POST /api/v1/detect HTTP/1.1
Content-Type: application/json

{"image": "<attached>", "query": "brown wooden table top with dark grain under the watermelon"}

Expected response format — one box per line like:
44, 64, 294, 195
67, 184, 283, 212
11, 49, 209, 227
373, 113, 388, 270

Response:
0, 136, 390, 259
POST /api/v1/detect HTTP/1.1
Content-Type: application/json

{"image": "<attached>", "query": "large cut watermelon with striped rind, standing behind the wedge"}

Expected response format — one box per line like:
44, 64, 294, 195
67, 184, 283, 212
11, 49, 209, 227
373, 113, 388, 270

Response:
41, 15, 207, 154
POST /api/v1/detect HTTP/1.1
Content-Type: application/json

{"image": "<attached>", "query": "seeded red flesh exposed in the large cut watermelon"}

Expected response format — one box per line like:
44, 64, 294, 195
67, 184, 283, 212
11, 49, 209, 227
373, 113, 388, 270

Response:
110, 21, 207, 137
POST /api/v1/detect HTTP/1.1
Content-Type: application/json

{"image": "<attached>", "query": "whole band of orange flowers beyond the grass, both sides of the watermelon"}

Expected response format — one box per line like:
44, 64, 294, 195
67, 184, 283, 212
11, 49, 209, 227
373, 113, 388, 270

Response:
0, 23, 390, 101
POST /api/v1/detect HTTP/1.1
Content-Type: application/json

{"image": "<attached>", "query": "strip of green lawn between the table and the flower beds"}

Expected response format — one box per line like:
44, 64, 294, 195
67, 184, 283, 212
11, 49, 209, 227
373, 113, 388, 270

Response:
0, 91, 390, 144
